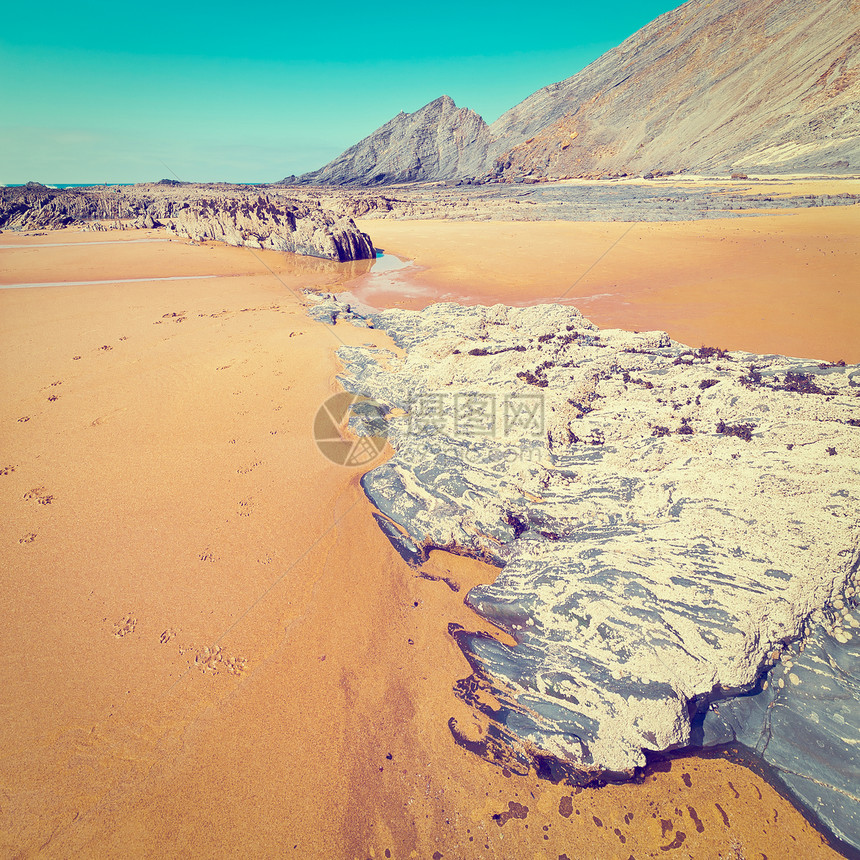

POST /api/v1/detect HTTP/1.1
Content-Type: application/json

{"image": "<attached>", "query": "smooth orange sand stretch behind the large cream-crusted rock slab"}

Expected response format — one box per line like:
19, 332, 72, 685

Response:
350, 206, 860, 362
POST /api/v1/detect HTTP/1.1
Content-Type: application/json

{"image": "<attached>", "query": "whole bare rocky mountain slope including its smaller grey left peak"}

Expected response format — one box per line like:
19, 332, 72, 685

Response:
294, 0, 860, 185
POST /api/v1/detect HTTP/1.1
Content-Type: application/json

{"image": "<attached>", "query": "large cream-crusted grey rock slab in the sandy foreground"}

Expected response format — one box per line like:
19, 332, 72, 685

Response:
311, 294, 860, 842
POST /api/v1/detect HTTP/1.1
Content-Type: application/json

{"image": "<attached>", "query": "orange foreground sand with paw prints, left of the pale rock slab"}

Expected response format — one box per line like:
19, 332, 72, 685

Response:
0, 232, 838, 860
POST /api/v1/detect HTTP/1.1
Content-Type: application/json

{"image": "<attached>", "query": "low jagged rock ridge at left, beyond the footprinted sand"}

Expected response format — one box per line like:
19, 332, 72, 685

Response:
0, 182, 375, 262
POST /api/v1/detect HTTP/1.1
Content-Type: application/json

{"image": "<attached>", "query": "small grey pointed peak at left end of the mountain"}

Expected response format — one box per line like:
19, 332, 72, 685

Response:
298, 96, 490, 185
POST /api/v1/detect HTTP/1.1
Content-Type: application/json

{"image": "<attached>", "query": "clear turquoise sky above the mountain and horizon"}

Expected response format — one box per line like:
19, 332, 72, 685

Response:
0, 0, 679, 184
